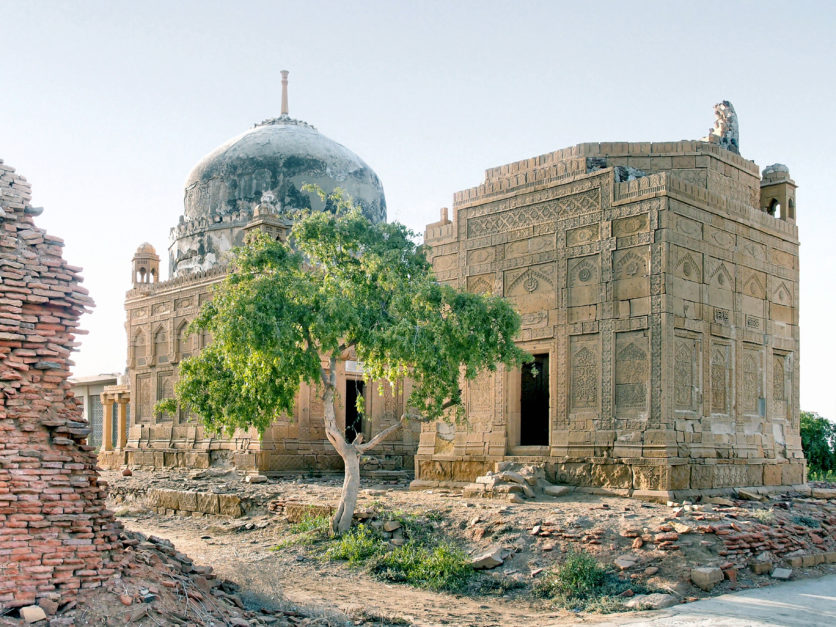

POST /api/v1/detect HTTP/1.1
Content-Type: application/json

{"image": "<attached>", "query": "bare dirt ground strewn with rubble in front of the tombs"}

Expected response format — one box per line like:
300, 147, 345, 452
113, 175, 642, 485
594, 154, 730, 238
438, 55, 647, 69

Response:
103, 470, 836, 627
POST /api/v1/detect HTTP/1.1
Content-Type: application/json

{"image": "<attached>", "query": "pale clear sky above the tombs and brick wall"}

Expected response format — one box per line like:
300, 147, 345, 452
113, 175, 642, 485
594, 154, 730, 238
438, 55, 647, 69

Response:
0, 0, 836, 418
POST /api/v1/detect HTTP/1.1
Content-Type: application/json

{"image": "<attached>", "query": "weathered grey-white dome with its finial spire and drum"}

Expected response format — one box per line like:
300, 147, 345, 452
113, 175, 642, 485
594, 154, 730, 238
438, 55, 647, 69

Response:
169, 76, 386, 277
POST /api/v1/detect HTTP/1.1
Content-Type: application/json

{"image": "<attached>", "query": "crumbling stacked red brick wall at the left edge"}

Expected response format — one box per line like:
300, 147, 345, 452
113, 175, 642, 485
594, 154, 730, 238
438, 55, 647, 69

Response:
0, 161, 122, 607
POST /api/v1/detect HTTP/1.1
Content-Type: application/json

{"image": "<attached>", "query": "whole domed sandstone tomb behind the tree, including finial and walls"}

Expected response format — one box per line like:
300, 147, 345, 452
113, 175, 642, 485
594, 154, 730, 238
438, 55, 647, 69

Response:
100, 74, 418, 472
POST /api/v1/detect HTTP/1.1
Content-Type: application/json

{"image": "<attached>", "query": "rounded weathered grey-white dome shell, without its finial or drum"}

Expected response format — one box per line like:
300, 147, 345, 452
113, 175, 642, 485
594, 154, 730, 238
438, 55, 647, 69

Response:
184, 115, 386, 222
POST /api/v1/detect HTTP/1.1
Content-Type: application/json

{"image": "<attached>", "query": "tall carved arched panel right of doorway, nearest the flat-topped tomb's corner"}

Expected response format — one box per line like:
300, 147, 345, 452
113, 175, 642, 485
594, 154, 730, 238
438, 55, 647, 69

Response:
615, 331, 650, 413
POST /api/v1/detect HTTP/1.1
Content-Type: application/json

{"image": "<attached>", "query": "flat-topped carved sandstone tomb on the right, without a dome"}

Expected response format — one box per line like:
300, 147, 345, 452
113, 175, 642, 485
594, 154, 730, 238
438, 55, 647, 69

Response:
416, 102, 805, 496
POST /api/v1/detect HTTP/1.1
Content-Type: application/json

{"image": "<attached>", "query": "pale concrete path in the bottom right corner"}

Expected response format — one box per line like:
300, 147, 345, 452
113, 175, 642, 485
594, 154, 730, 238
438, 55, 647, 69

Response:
595, 575, 836, 627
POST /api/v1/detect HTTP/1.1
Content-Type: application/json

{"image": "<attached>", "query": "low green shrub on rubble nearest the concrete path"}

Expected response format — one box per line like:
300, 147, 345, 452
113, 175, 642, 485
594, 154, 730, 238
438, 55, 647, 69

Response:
534, 551, 652, 614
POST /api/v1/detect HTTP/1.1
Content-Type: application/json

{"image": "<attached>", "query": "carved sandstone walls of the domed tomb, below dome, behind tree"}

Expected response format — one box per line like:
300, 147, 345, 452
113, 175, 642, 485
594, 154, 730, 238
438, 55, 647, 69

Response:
113, 267, 418, 472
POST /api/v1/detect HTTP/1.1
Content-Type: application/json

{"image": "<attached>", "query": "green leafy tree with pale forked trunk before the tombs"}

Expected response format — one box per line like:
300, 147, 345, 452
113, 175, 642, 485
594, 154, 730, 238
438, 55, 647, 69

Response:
160, 193, 528, 533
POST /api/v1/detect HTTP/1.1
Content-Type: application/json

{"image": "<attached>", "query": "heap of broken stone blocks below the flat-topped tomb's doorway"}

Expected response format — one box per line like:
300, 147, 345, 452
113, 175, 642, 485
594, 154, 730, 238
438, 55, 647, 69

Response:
463, 462, 571, 503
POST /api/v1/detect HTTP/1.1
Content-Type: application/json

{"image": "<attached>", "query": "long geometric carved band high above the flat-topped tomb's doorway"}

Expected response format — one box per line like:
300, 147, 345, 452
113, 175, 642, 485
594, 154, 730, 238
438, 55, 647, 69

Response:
467, 188, 600, 237
